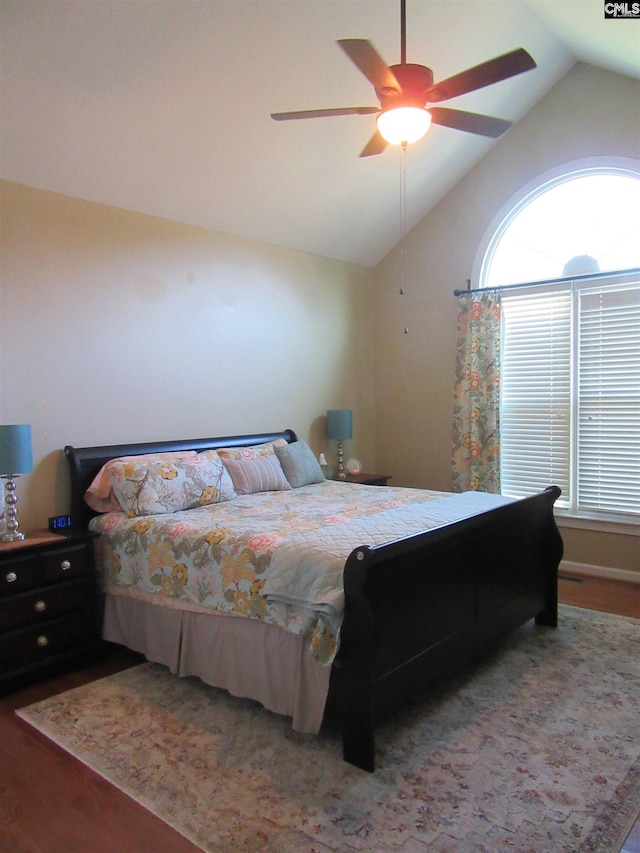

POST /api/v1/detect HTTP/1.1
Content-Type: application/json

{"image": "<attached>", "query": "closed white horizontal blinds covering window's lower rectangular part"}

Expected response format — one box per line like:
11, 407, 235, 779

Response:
500, 277, 640, 518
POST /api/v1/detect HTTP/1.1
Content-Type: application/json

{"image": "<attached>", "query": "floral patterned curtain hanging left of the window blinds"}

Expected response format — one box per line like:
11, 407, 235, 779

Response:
453, 292, 500, 493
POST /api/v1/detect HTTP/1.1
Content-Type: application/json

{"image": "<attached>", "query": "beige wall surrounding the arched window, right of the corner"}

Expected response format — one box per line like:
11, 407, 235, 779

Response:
375, 64, 640, 572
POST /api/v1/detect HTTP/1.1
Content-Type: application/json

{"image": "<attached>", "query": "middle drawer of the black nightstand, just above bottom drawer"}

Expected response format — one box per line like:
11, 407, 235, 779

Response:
0, 579, 95, 642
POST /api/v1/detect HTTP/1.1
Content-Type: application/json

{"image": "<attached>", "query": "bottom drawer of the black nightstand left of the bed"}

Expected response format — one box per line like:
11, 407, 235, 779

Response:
0, 607, 96, 675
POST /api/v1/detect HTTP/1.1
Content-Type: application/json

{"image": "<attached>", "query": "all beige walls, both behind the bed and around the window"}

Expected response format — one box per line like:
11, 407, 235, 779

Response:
0, 64, 640, 571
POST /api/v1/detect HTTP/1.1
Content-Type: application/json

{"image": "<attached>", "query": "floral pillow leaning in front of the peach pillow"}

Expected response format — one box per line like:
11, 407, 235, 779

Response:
106, 455, 236, 517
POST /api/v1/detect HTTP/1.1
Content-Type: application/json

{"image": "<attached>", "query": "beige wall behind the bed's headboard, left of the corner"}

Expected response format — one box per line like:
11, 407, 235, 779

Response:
0, 182, 375, 529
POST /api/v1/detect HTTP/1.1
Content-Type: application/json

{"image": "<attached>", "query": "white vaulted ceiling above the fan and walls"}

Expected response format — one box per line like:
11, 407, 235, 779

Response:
0, 0, 640, 266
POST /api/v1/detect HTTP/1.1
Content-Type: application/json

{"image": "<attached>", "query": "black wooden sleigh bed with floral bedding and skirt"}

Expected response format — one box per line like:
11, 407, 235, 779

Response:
65, 430, 562, 771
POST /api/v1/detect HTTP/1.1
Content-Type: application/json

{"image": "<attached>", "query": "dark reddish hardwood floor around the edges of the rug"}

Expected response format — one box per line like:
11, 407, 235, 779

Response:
0, 576, 640, 853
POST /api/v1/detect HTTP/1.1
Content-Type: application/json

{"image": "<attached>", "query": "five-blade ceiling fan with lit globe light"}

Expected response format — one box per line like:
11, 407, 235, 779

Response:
271, 0, 536, 157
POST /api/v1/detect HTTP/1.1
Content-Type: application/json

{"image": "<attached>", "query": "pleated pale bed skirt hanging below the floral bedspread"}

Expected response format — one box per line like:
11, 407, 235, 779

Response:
102, 594, 331, 734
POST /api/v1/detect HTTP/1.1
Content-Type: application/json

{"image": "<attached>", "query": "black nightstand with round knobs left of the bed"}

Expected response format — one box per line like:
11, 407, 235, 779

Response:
0, 530, 102, 692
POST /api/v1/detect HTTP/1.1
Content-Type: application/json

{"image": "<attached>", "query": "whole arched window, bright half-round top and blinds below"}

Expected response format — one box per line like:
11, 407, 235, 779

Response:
475, 156, 640, 524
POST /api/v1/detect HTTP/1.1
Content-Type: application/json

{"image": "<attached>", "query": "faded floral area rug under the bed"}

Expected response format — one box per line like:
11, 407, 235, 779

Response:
17, 607, 640, 853
